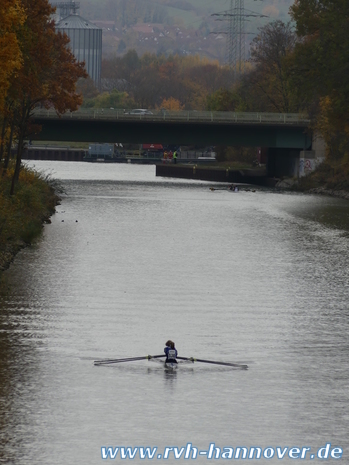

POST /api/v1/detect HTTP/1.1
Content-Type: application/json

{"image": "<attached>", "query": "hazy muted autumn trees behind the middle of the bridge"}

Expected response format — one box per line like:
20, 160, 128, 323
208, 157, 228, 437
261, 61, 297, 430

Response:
102, 50, 230, 110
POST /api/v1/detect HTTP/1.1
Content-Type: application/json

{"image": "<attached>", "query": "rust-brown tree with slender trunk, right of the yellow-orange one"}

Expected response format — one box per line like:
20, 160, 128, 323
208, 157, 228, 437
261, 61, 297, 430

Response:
8, 0, 87, 194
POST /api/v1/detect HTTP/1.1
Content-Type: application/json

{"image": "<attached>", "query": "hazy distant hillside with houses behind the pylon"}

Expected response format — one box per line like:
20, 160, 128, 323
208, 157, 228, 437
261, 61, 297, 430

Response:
80, 0, 293, 63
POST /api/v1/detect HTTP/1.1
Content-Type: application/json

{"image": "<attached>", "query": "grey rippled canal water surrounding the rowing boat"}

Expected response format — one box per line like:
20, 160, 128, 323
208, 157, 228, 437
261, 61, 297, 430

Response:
0, 162, 349, 465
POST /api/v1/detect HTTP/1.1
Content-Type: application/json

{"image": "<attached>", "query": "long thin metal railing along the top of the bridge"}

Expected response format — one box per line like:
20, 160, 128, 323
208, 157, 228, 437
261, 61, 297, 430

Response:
34, 108, 309, 125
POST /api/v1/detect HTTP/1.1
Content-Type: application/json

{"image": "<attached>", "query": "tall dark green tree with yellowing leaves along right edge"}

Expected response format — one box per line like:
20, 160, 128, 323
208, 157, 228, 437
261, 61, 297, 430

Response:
290, 0, 349, 160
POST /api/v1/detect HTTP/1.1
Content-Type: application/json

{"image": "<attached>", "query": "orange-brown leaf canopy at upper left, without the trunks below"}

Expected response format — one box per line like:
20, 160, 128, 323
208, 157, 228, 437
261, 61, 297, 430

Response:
0, 0, 86, 112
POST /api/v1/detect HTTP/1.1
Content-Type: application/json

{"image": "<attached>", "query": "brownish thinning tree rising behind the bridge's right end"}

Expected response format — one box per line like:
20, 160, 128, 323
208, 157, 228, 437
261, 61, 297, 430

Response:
207, 20, 300, 113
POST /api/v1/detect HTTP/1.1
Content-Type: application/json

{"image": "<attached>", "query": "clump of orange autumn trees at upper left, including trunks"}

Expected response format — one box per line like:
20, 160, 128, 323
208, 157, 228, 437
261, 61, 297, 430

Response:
0, 0, 87, 195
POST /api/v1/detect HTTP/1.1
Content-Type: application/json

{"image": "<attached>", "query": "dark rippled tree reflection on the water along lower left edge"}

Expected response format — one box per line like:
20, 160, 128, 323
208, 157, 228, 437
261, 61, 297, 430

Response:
0, 277, 40, 463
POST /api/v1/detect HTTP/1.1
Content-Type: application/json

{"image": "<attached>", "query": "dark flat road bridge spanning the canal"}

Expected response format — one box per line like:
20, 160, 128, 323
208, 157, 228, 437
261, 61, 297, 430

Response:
31, 109, 312, 150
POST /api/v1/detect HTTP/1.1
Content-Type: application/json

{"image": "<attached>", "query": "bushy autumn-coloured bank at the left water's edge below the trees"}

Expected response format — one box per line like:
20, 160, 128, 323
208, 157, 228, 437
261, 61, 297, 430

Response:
0, 163, 59, 272
